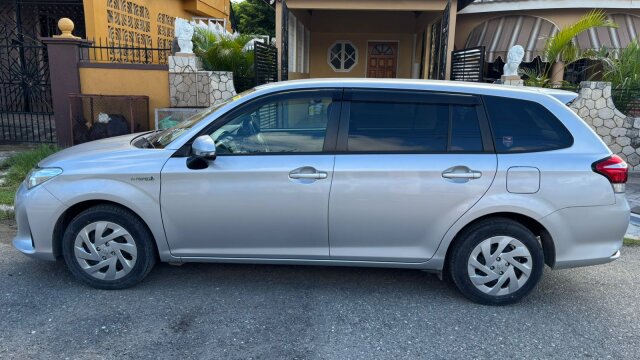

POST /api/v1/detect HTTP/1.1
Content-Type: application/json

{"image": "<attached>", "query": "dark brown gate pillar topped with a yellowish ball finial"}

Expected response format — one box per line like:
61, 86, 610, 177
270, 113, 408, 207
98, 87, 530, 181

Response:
40, 18, 90, 146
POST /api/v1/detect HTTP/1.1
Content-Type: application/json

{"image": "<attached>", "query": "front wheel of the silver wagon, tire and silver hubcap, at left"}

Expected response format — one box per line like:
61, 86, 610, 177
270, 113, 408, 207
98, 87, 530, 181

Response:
62, 205, 156, 290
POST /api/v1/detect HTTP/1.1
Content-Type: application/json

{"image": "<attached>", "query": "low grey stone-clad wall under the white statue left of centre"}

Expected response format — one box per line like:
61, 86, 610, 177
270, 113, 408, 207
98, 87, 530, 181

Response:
169, 54, 236, 107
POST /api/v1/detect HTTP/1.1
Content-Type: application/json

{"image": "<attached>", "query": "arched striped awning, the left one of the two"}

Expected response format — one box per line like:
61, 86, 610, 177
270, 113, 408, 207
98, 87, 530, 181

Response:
466, 15, 558, 62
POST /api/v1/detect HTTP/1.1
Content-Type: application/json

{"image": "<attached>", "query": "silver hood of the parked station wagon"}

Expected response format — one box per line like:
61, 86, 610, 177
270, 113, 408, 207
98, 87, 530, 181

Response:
38, 133, 168, 169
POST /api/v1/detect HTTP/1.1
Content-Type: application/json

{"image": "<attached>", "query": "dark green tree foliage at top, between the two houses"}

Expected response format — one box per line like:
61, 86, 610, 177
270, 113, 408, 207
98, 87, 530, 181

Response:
232, 0, 276, 37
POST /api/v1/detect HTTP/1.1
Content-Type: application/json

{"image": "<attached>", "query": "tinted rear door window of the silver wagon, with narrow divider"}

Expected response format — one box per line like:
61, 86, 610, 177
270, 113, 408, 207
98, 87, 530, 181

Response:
347, 101, 483, 152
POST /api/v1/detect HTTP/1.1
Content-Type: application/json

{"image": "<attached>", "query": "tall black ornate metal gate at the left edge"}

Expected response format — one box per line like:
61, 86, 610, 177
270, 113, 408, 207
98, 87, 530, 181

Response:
0, 0, 85, 142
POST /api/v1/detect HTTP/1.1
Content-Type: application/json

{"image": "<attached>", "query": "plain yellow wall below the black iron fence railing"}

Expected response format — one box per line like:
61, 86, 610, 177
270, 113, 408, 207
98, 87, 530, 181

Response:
80, 68, 169, 129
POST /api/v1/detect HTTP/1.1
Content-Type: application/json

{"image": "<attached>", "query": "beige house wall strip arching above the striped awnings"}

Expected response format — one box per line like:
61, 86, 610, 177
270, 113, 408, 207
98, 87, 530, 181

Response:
455, 9, 640, 49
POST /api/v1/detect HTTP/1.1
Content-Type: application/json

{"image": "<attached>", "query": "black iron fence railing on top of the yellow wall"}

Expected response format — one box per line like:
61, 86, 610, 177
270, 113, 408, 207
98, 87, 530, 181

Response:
80, 39, 171, 65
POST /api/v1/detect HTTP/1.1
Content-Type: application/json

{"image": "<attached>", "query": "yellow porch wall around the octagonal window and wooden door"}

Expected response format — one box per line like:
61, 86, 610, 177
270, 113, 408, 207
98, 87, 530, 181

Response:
309, 32, 413, 78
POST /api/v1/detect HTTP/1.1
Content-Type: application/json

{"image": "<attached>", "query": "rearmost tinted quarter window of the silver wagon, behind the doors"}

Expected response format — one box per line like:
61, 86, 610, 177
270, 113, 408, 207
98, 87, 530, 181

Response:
485, 96, 573, 153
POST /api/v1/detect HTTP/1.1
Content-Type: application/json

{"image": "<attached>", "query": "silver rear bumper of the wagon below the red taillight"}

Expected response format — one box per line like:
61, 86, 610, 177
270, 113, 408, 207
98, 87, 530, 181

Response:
540, 194, 630, 269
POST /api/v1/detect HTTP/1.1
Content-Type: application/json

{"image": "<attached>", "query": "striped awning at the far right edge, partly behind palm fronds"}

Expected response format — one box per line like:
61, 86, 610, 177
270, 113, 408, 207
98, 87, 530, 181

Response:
576, 14, 640, 52
